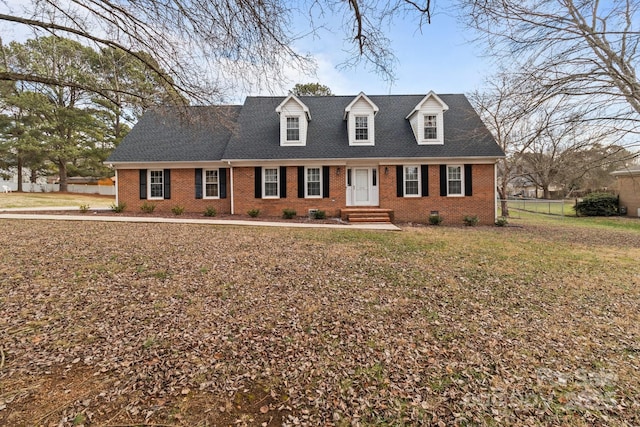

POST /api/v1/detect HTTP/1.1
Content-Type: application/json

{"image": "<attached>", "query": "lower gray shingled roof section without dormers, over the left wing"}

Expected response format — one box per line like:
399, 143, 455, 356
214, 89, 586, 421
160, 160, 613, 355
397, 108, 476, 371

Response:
106, 105, 242, 163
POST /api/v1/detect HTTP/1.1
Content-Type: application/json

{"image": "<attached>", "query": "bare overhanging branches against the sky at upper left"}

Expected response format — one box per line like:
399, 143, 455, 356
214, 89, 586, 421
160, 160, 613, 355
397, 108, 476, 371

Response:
0, 0, 431, 103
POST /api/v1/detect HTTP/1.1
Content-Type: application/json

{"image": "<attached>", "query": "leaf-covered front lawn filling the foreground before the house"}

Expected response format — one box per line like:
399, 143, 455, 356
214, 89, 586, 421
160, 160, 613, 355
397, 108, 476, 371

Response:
0, 220, 640, 426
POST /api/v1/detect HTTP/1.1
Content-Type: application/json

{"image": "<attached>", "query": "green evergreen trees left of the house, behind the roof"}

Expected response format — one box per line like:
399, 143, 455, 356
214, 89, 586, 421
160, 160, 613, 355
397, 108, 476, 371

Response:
0, 36, 179, 191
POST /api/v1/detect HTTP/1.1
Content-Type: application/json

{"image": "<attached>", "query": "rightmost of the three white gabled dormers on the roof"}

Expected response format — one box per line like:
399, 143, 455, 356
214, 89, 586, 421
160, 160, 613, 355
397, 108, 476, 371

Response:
406, 91, 449, 145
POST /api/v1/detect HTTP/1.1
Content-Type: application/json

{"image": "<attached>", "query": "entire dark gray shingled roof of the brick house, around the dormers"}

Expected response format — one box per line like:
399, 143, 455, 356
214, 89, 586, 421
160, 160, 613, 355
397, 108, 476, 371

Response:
107, 95, 504, 162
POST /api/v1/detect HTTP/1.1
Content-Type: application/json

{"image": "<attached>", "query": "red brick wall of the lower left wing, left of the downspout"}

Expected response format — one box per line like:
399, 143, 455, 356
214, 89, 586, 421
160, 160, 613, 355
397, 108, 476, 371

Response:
116, 169, 231, 214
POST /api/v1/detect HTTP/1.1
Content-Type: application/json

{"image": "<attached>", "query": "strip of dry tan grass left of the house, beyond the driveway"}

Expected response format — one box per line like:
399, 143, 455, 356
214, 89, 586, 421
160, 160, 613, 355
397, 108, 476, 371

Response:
0, 192, 115, 209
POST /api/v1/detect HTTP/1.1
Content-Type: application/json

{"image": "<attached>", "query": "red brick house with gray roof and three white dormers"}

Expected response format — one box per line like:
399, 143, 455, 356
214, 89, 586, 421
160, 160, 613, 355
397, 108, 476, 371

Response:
106, 92, 504, 224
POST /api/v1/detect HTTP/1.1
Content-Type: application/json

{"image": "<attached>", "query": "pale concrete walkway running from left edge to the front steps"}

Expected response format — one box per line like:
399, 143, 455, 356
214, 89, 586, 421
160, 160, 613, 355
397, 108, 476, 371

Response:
0, 206, 400, 231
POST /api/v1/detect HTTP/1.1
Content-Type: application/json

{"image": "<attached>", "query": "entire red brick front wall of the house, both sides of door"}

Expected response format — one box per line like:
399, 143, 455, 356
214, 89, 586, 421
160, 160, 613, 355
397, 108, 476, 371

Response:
117, 165, 495, 225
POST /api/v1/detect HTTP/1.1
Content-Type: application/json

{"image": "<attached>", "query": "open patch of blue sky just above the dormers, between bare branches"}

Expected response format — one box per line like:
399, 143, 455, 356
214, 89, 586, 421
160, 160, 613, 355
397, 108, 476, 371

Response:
278, 8, 491, 95
